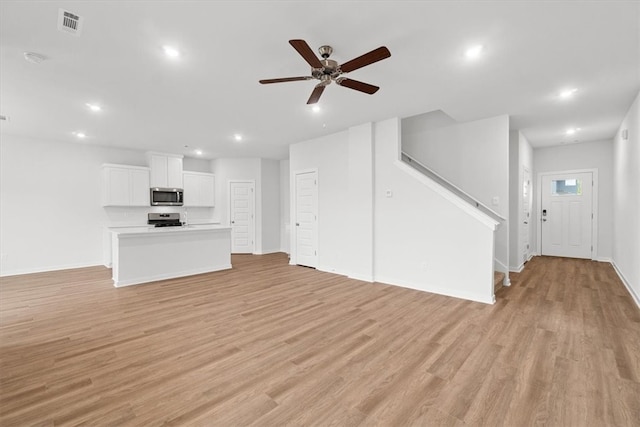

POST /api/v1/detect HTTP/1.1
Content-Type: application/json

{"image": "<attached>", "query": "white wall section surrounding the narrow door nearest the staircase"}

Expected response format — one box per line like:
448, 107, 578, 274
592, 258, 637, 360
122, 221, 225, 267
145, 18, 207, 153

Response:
289, 131, 350, 275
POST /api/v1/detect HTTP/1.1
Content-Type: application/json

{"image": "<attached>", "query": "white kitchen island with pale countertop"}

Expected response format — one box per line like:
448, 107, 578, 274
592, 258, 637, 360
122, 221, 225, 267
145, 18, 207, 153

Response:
111, 225, 231, 287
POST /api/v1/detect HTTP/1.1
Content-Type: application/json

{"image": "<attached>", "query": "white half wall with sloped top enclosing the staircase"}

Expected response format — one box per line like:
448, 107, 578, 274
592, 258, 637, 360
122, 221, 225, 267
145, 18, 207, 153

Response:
374, 119, 494, 302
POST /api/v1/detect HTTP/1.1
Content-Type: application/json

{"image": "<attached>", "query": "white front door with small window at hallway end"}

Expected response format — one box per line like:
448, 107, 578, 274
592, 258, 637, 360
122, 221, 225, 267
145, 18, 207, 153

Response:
540, 172, 593, 259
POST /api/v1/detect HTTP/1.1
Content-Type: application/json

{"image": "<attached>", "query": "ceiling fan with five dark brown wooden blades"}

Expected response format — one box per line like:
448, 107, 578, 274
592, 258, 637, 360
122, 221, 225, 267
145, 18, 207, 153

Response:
260, 40, 391, 104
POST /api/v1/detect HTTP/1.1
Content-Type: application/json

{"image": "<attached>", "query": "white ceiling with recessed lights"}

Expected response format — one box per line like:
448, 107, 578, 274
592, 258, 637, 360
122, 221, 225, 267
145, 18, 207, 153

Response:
0, 0, 640, 158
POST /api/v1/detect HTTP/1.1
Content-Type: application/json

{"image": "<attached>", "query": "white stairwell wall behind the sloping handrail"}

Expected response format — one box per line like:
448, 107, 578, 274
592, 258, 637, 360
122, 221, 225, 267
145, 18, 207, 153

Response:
402, 115, 509, 272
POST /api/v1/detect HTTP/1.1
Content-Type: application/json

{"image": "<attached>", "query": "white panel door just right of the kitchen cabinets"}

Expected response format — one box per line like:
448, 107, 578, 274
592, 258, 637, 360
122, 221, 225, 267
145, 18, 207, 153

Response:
229, 181, 255, 254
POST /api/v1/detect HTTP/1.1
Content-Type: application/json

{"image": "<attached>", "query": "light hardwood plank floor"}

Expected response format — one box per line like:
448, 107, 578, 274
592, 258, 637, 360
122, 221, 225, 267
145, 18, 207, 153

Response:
0, 254, 640, 426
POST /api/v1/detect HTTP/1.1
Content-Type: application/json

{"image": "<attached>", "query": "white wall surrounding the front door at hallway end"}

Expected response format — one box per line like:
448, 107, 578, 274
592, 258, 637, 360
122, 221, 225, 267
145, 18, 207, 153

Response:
533, 141, 613, 261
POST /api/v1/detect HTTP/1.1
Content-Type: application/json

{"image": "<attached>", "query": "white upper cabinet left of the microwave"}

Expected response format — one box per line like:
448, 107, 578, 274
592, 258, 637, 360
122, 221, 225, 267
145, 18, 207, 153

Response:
102, 164, 150, 206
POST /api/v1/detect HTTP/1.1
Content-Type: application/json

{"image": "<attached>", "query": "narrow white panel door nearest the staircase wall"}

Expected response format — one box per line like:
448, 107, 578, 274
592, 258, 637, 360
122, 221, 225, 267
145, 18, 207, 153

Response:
295, 171, 318, 268
